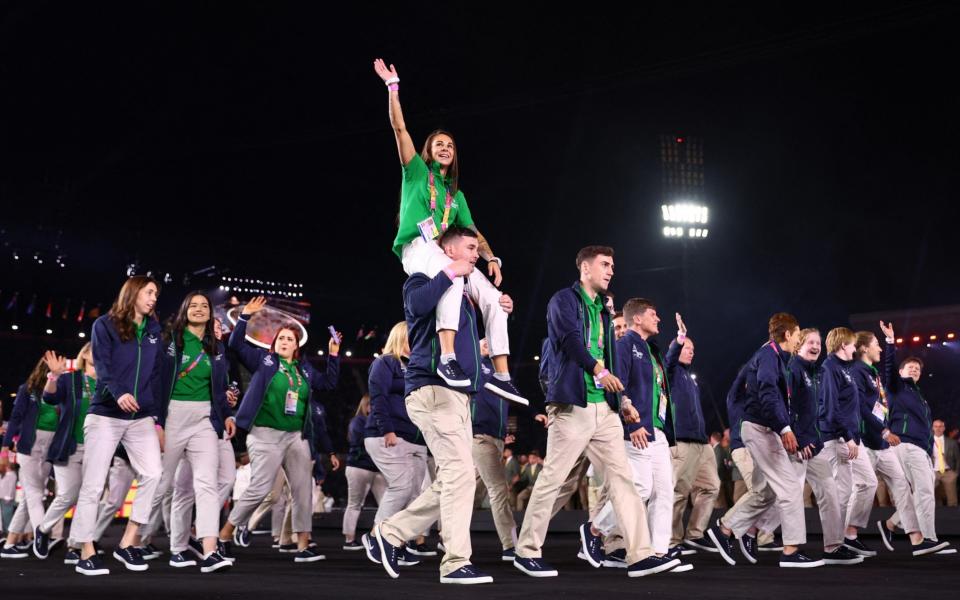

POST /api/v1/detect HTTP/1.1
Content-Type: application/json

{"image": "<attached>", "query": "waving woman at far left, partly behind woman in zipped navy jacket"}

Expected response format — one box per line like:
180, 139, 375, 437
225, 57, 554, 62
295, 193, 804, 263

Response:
33, 342, 97, 565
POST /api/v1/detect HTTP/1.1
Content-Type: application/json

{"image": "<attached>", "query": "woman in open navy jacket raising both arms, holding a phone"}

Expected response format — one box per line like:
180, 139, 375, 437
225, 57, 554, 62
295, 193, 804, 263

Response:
220, 296, 340, 563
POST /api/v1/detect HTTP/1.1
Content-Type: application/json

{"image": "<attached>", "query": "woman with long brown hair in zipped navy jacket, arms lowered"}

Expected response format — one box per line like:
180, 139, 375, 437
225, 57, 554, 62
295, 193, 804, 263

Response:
71, 275, 163, 575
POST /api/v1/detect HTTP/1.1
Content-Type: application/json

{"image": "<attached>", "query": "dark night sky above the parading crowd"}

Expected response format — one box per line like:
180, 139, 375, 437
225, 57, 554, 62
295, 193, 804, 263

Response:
0, 2, 960, 422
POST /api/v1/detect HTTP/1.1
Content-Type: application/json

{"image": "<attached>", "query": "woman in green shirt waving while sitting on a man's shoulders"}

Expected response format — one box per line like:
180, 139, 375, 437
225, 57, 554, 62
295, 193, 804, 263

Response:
373, 58, 527, 404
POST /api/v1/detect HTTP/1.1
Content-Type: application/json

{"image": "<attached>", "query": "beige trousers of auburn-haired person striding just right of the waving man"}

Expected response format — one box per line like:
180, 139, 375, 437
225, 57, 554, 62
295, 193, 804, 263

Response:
722, 421, 807, 546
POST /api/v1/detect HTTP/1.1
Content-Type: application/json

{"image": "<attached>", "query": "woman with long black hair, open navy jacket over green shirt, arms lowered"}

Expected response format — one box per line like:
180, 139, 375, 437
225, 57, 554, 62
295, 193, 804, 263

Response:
141, 291, 236, 573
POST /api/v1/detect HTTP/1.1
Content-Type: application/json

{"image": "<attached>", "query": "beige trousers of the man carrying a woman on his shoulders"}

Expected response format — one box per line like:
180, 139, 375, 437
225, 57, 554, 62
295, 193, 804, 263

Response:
380, 385, 476, 576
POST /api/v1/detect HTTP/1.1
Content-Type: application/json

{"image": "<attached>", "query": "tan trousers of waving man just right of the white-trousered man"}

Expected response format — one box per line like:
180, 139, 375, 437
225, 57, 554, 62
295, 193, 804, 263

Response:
658, 442, 720, 551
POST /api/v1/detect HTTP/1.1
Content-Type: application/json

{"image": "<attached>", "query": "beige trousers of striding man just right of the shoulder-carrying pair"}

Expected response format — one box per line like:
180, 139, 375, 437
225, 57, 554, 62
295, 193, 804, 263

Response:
517, 402, 653, 564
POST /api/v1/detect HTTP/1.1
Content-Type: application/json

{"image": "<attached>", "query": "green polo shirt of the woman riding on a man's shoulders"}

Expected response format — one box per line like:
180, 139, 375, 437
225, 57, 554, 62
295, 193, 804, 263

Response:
393, 154, 473, 258
